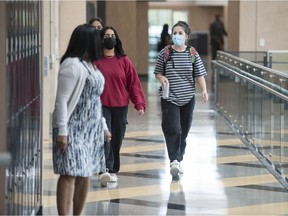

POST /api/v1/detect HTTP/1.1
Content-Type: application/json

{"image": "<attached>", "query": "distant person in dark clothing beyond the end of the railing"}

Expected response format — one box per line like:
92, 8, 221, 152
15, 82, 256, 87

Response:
209, 15, 228, 60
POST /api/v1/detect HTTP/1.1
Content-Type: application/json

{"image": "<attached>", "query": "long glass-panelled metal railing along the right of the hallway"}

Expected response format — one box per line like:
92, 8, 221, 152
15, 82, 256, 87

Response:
212, 51, 288, 190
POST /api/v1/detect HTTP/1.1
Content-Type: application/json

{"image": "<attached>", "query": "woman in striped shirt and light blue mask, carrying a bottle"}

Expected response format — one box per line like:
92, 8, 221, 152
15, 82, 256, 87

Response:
154, 21, 208, 178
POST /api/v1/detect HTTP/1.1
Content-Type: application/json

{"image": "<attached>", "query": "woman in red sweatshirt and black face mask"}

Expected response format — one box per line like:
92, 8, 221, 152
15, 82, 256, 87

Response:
94, 26, 146, 182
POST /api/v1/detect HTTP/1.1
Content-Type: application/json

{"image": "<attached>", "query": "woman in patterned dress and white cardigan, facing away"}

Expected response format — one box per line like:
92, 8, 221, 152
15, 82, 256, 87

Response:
53, 24, 107, 215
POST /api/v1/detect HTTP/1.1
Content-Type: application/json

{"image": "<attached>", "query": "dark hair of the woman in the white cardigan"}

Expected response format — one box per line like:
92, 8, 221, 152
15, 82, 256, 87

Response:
60, 24, 103, 63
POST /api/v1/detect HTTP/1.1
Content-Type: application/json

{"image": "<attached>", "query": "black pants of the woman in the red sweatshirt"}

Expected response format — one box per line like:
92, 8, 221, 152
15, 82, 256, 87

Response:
103, 106, 128, 173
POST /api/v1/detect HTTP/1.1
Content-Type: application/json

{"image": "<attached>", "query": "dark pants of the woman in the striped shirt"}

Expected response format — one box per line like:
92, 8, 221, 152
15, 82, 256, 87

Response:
161, 96, 195, 162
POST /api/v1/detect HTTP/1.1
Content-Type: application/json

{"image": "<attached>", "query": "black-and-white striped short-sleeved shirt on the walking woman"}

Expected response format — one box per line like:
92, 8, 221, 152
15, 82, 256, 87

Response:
154, 46, 207, 106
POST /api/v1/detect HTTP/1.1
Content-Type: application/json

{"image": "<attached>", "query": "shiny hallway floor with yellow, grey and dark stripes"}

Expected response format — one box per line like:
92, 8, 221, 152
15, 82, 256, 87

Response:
43, 59, 288, 215
